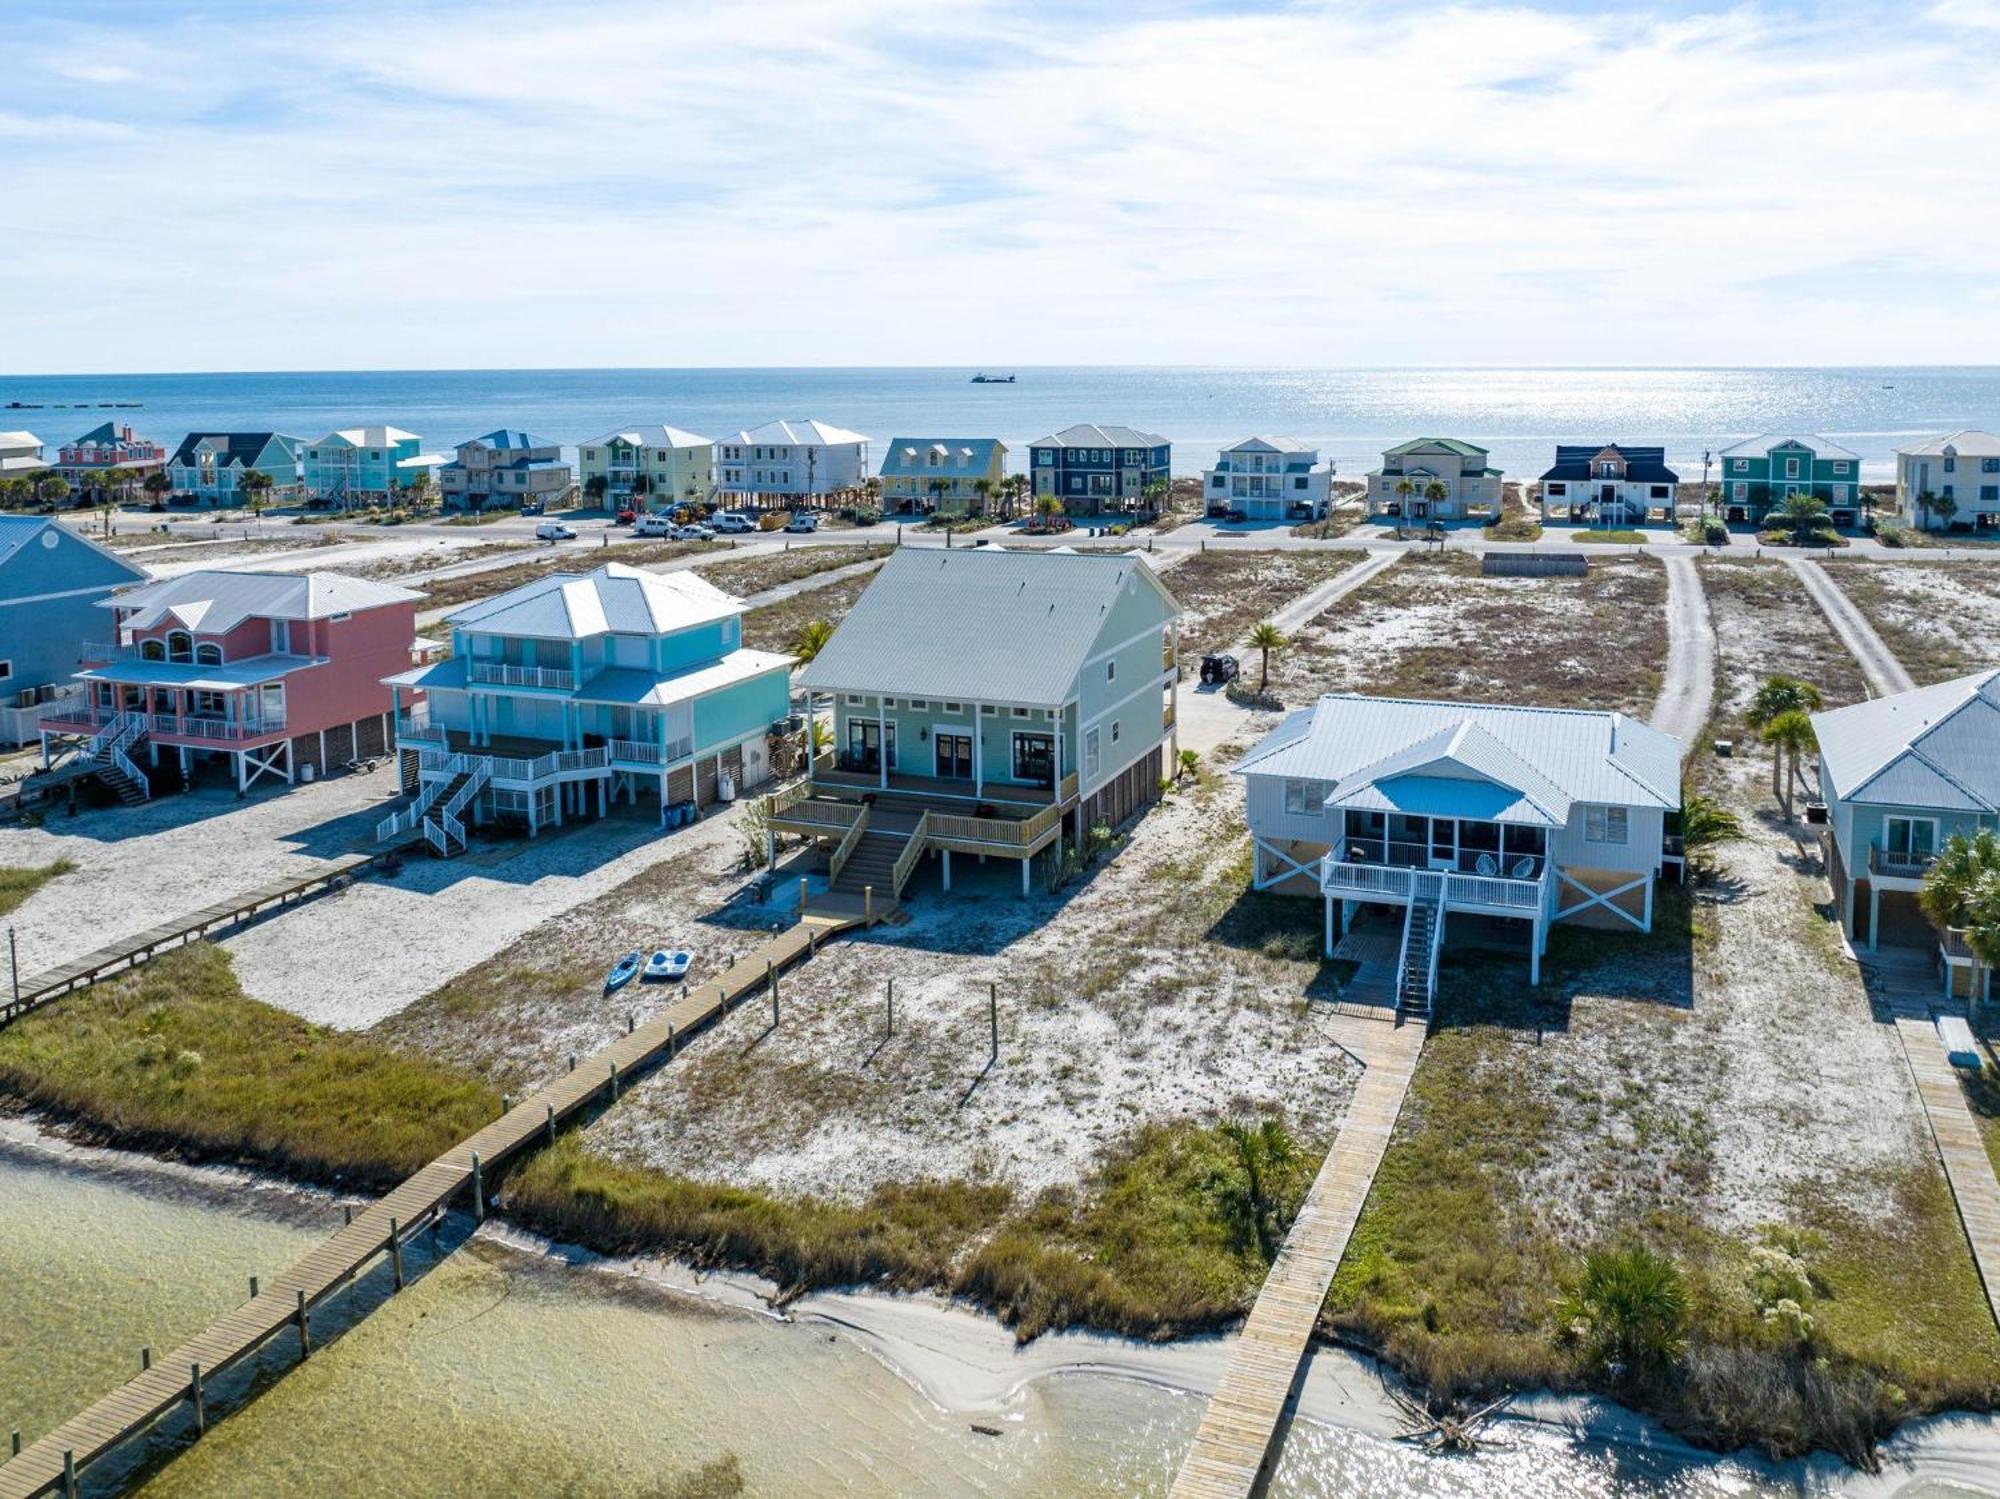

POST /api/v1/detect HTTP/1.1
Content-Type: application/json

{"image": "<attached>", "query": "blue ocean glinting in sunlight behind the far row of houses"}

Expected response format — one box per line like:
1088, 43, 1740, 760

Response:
0, 366, 2000, 480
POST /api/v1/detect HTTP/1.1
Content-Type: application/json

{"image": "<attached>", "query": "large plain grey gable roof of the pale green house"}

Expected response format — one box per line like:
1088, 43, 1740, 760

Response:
798, 548, 1180, 708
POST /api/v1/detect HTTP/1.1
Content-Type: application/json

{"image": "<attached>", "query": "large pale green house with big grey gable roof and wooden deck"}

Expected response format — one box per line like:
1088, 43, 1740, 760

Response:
770, 548, 1180, 899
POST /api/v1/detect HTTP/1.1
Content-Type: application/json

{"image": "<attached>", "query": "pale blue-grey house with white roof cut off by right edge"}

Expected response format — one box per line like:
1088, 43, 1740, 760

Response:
1812, 670, 2000, 993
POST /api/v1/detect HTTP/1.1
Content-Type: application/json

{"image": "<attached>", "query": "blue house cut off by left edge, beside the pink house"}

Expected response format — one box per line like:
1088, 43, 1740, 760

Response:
0, 516, 146, 746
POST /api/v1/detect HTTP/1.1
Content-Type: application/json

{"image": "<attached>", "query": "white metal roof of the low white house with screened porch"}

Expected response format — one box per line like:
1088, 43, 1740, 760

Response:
1234, 692, 1680, 827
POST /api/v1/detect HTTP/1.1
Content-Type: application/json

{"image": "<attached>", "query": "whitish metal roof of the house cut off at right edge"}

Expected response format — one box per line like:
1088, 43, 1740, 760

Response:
1812, 670, 2000, 811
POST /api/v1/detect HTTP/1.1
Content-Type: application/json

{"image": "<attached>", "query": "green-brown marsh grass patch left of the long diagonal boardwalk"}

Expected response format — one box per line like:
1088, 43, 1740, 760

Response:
0, 943, 500, 1185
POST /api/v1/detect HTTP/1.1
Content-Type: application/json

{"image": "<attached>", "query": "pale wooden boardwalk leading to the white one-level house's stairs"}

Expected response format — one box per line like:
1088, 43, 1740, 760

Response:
1172, 1025, 1424, 1499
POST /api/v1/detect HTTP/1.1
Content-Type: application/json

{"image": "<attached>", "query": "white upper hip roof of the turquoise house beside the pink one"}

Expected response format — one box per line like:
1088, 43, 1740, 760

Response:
444, 562, 744, 640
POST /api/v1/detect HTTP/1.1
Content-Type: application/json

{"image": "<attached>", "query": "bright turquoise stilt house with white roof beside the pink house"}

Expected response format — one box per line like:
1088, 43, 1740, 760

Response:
378, 562, 792, 853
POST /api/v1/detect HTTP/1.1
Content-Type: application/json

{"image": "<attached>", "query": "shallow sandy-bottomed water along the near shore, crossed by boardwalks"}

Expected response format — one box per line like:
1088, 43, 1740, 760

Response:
0, 1141, 2000, 1499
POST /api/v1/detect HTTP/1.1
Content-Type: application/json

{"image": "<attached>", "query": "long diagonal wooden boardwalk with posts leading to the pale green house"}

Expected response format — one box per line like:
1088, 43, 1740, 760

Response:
0, 905, 876, 1499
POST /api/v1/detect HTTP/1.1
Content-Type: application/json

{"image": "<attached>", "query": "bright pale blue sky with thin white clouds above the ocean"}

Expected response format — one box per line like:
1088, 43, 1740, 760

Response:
0, 0, 2000, 374
